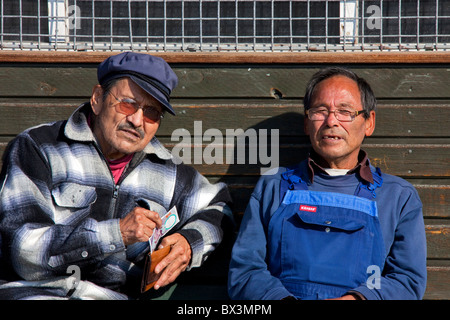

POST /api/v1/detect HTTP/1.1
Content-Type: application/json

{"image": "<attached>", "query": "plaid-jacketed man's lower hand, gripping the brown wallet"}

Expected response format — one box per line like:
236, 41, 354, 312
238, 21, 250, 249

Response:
154, 233, 191, 290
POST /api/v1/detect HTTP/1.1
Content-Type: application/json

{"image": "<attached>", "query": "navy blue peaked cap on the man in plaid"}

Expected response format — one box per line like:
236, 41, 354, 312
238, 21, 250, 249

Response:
97, 52, 178, 115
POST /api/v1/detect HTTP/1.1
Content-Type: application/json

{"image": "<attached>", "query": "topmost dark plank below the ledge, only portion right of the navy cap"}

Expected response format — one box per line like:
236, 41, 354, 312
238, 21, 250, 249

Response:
173, 65, 450, 99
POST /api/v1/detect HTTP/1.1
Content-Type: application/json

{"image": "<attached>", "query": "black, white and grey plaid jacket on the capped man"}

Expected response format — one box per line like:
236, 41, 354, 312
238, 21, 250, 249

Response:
0, 104, 232, 296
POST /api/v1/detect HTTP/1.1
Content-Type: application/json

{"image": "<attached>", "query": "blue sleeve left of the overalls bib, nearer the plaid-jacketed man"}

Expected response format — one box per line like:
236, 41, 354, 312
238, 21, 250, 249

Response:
228, 172, 291, 300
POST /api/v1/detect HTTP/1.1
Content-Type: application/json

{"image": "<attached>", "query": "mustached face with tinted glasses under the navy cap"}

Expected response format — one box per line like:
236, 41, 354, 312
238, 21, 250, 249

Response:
91, 78, 163, 159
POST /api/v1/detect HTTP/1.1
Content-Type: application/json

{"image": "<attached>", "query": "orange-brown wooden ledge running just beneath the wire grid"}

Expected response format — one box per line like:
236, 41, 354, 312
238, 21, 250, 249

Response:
0, 50, 450, 64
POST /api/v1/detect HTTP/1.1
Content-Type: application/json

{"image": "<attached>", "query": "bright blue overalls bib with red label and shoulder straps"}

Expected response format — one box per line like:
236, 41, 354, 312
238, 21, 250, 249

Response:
268, 168, 385, 299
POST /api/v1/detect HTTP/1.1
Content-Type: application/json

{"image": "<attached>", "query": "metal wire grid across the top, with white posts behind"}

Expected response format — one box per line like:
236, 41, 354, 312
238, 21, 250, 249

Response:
0, 0, 450, 52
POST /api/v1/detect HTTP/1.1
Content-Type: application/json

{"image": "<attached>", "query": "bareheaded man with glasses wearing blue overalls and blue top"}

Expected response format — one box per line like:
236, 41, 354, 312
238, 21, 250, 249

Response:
228, 68, 426, 300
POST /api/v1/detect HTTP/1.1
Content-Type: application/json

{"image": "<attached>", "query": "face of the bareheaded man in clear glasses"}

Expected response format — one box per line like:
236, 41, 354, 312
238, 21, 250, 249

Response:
305, 75, 375, 169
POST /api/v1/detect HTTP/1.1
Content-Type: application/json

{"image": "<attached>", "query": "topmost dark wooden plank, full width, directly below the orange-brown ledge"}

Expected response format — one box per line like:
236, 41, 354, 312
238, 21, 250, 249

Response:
0, 64, 450, 99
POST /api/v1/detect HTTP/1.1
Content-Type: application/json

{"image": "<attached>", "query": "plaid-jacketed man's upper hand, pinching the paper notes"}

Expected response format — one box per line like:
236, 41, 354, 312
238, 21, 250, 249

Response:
119, 207, 162, 246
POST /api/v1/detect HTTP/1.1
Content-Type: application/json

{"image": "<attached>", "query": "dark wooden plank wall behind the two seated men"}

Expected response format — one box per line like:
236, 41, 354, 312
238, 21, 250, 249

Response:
0, 52, 450, 300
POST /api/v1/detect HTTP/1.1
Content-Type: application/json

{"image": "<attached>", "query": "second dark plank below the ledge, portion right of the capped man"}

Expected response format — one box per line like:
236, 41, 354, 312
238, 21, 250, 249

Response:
158, 102, 450, 137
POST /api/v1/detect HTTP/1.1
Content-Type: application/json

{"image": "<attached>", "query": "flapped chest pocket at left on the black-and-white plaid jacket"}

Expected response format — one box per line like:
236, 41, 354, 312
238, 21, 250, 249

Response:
52, 182, 97, 208
